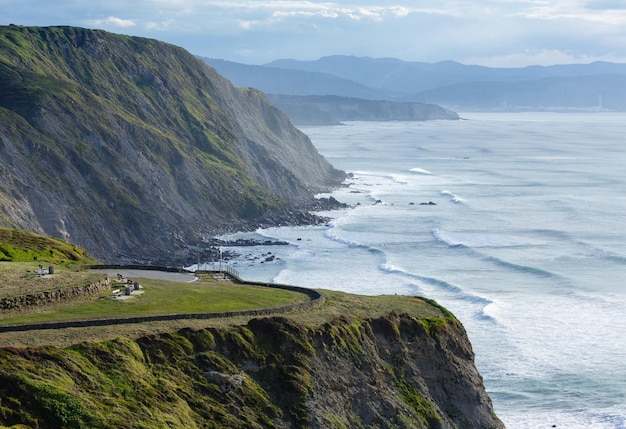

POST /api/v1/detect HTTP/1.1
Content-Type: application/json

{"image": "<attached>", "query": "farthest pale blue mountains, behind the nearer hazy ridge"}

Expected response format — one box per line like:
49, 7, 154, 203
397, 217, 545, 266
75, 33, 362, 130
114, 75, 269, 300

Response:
258, 55, 626, 110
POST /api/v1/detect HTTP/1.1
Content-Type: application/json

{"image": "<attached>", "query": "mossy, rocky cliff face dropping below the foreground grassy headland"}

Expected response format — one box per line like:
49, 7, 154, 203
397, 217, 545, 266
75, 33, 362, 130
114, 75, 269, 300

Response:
0, 314, 503, 428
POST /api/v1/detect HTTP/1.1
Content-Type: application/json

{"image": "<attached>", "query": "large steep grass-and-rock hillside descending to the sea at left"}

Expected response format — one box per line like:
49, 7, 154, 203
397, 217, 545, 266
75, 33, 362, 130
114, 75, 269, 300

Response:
0, 26, 344, 261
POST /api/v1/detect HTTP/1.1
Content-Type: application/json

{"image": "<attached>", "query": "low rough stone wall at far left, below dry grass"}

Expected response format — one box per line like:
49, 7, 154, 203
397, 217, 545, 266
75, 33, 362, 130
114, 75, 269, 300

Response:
0, 277, 111, 310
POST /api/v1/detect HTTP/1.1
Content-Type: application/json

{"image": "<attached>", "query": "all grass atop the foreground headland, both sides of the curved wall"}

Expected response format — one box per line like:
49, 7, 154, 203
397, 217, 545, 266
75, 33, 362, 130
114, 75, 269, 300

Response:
0, 228, 454, 347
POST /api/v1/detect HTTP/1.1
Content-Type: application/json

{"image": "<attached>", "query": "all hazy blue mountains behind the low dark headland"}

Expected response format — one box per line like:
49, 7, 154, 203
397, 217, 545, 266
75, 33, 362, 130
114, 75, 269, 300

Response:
203, 55, 626, 111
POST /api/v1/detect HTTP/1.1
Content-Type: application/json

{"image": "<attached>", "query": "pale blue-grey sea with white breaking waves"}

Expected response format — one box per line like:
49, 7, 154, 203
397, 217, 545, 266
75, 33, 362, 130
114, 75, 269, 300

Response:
212, 112, 626, 429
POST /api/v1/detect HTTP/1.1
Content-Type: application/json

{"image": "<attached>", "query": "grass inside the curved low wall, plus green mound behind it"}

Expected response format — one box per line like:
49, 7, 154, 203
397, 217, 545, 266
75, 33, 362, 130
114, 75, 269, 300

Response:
0, 228, 308, 325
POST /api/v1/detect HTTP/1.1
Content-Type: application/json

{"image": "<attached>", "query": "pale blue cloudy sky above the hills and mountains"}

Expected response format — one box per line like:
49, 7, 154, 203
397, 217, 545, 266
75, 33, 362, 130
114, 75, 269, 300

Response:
0, 0, 626, 67
